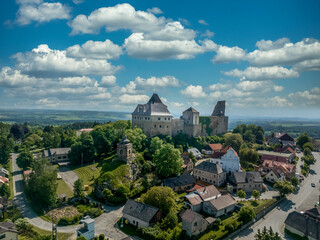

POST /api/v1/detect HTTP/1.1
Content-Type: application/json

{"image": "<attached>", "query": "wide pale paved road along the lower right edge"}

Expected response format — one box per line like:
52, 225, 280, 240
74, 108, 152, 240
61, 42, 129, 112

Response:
233, 153, 320, 240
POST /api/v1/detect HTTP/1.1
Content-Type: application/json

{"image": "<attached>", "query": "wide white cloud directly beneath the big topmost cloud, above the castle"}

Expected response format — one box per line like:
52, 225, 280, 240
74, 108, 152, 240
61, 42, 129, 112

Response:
124, 33, 216, 60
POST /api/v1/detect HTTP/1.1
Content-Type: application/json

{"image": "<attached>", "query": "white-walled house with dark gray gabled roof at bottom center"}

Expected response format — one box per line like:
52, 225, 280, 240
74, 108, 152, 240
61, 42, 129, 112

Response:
122, 199, 161, 228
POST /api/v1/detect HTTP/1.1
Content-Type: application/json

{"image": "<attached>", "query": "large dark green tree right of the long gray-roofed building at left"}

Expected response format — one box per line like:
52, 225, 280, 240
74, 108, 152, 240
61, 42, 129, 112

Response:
68, 134, 94, 165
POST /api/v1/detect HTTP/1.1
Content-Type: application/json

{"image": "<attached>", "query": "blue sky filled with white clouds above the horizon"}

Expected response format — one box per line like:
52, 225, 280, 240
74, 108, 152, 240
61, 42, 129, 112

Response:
0, 0, 320, 118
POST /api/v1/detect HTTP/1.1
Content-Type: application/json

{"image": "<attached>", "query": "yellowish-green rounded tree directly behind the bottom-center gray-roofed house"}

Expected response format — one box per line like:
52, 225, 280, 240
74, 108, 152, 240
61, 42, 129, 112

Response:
141, 186, 176, 214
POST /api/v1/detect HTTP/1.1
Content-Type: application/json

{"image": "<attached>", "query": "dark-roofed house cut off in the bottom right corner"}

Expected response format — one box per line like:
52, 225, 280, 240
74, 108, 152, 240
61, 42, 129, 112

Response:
284, 207, 320, 240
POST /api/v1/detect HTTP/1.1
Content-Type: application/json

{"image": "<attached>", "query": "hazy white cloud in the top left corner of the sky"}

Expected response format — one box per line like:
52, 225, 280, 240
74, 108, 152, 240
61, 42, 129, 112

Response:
16, 0, 71, 25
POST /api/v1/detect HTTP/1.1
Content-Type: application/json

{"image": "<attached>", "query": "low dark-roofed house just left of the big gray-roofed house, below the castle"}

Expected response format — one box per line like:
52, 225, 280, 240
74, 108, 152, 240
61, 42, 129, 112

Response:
162, 174, 195, 191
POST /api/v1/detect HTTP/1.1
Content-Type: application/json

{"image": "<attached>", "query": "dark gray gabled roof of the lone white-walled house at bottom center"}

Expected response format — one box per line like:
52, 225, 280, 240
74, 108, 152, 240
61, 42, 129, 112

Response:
122, 199, 159, 222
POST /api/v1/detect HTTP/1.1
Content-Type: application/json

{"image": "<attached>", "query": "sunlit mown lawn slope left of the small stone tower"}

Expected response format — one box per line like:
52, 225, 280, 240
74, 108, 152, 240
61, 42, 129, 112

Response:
72, 163, 102, 194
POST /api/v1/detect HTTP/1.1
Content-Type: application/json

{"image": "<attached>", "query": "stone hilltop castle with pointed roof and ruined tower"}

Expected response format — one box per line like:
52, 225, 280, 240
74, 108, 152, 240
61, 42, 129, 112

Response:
132, 93, 228, 138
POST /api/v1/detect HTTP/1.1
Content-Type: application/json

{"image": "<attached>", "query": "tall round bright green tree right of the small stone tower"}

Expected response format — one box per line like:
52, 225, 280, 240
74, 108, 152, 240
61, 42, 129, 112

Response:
153, 143, 183, 178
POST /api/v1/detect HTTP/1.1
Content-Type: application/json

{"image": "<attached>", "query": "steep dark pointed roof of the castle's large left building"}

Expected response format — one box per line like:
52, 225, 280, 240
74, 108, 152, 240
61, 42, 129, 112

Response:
132, 93, 172, 116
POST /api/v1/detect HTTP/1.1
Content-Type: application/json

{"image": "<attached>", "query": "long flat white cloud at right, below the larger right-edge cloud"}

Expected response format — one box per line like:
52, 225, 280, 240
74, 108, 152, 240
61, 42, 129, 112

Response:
223, 66, 299, 81
